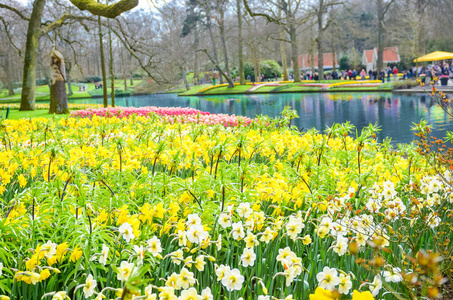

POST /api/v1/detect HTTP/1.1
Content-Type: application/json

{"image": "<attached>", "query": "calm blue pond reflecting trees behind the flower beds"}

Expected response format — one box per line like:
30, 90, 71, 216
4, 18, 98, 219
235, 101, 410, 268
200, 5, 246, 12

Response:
70, 93, 453, 143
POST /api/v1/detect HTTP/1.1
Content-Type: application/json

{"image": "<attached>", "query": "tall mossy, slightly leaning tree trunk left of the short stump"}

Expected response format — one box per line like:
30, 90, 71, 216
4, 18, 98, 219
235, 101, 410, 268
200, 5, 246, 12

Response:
20, 0, 46, 110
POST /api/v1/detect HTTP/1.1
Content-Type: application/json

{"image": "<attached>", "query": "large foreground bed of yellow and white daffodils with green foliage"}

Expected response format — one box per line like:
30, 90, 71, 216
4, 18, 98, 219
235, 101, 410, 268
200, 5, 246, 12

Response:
0, 110, 453, 300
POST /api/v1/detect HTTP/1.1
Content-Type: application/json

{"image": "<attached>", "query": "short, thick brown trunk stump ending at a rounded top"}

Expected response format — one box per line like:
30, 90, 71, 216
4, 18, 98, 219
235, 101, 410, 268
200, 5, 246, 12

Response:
49, 50, 69, 114
